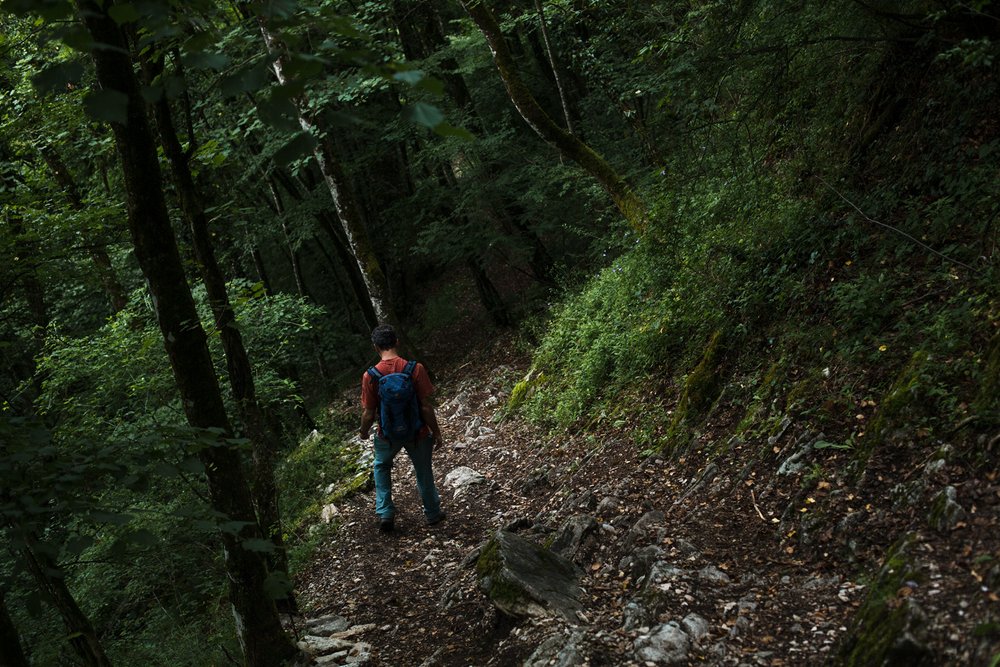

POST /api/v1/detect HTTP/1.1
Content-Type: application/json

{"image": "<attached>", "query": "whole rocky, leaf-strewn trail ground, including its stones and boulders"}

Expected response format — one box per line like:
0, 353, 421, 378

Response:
297, 342, 1000, 666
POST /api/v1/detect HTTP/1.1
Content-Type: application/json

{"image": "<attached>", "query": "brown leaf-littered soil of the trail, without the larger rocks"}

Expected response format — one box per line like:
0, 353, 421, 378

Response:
297, 332, 1000, 665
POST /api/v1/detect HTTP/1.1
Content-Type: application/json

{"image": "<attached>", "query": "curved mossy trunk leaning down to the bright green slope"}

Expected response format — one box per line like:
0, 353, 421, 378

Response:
461, 0, 647, 232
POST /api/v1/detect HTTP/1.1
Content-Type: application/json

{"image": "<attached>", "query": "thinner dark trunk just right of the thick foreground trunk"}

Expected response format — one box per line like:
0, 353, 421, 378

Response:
140, 48, 296, 612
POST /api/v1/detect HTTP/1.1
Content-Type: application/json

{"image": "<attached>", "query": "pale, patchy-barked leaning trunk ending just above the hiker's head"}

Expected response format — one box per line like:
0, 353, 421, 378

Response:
257, 17, 404, 328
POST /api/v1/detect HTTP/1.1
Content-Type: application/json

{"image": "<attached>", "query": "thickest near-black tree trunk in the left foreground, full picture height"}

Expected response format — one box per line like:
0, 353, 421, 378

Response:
77, 0, 297, 667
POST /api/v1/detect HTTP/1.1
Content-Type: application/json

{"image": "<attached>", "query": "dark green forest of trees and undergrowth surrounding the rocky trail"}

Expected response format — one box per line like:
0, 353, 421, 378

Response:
0, 0, 1000, 665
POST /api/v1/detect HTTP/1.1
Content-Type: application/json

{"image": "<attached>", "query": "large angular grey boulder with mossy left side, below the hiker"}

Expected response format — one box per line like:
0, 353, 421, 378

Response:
476, 530, 583, 622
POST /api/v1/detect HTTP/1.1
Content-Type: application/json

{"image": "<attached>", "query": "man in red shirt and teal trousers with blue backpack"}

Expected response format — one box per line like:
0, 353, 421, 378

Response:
361, 324, 445, 533
